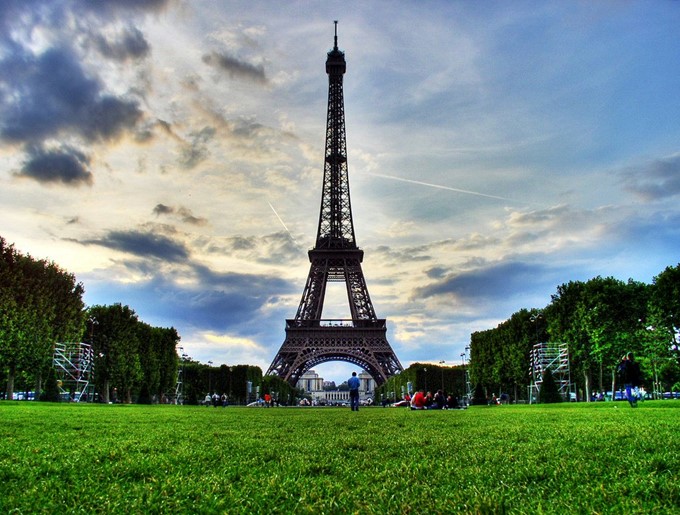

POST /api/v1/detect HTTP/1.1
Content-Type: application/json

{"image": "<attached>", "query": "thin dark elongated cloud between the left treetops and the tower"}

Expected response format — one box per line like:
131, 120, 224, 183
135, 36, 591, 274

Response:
82, 231, 189, 263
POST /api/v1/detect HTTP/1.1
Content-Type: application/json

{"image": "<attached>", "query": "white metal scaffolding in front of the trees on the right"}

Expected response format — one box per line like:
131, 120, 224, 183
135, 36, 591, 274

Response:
529, 342, 571, 403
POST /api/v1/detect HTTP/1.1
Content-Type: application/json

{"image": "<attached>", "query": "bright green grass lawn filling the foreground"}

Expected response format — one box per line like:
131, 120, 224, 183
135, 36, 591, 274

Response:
0, 401, 680, 514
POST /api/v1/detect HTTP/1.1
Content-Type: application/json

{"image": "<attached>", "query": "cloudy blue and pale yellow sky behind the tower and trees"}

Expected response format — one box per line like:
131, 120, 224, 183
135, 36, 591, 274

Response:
0, 0, 680, 381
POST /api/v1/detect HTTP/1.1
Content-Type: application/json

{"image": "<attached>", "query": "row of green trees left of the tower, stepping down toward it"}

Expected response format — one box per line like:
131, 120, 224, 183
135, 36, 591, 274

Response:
0, 237, 299, 404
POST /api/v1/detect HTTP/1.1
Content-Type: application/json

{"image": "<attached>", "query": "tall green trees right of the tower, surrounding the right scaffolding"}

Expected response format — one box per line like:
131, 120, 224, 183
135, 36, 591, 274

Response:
469, 265, 680, 400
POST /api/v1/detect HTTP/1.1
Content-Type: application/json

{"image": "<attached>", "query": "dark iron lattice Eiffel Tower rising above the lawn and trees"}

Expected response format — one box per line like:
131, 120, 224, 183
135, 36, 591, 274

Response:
267, 21, 403, 386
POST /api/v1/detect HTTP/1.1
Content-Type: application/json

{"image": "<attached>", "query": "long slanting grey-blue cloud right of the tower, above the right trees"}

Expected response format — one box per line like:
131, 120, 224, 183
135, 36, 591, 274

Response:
415, 262, 549, 301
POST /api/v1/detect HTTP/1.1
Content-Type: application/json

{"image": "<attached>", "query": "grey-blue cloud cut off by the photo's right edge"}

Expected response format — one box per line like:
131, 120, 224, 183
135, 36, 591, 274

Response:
621, 154, 680, 202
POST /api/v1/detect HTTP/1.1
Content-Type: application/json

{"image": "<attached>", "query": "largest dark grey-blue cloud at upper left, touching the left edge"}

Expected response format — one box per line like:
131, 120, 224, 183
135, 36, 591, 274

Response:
0, 48, 142, 142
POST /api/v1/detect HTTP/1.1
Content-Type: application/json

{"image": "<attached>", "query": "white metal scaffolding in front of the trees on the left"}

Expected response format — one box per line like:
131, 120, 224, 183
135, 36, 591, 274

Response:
53, 342, 94, 402
